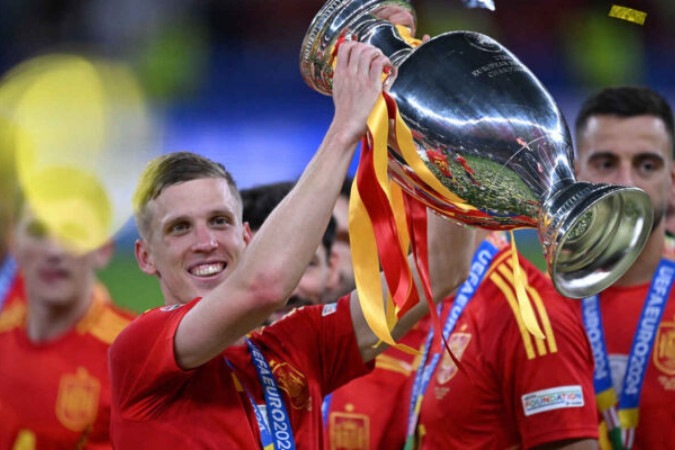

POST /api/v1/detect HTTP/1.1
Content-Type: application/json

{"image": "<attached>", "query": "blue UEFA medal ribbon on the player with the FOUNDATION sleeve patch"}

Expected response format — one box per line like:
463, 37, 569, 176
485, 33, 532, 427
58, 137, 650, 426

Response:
405, 239, 501, 450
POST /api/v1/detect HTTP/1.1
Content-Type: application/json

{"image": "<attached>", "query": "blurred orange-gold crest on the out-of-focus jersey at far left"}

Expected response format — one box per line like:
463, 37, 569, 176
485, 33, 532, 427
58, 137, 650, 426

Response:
56, 367, 101, 432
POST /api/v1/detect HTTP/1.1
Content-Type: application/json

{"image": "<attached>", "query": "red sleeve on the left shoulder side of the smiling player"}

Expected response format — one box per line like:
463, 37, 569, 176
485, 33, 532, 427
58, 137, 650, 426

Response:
109, 301, 197, 419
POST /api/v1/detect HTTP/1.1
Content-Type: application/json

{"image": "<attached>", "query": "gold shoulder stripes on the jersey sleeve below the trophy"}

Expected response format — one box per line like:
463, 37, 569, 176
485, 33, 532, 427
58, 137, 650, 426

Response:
490, 250, 558, 359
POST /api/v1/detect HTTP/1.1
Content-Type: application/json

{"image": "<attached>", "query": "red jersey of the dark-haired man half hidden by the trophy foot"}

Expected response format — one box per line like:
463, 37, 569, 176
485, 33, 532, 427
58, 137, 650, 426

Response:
588, 283, 675, 450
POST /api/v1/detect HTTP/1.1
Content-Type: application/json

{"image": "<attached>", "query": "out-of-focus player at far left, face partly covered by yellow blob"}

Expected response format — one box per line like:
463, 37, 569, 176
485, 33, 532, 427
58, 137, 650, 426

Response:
0, 171, 132, 449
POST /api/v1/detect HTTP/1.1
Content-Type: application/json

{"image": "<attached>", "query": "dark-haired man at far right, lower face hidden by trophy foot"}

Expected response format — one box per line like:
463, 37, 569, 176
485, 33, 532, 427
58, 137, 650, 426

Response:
575, 86, 675, 450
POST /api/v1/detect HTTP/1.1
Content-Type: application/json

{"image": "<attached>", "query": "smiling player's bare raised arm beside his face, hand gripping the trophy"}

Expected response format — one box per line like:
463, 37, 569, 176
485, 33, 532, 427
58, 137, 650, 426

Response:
174, 42, 389, 369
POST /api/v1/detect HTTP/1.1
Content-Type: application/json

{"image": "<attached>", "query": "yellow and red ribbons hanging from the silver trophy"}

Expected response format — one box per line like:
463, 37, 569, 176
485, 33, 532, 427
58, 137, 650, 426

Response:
344, 29, 544, 356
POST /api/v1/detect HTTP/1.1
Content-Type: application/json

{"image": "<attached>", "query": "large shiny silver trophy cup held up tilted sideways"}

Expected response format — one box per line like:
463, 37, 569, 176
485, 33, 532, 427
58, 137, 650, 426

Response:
300, 0, 653, 298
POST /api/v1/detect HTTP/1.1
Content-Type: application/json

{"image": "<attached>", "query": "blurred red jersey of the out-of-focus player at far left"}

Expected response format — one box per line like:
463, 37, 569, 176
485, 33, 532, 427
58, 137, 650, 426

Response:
0, 286, 132, 449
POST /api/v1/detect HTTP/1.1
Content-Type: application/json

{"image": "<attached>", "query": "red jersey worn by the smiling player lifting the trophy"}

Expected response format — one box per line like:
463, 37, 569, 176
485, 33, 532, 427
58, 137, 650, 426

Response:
110, 297, 371, 450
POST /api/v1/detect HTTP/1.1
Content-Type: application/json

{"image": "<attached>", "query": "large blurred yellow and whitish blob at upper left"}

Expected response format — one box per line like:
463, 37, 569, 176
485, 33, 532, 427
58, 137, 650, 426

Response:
0, 54, 154, 251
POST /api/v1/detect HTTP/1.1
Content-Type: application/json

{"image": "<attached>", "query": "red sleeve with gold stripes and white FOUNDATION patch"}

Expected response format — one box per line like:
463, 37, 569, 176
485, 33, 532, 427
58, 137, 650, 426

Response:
501, 270, 598, 448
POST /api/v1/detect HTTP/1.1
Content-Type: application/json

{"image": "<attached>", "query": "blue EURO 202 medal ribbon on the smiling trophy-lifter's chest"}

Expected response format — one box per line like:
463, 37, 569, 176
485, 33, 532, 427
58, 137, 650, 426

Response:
225, 338, 295, 450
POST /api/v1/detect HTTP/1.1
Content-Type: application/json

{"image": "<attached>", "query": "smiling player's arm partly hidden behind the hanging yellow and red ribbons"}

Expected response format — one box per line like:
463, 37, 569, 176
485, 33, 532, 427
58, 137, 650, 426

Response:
350, 212, 476, 361
